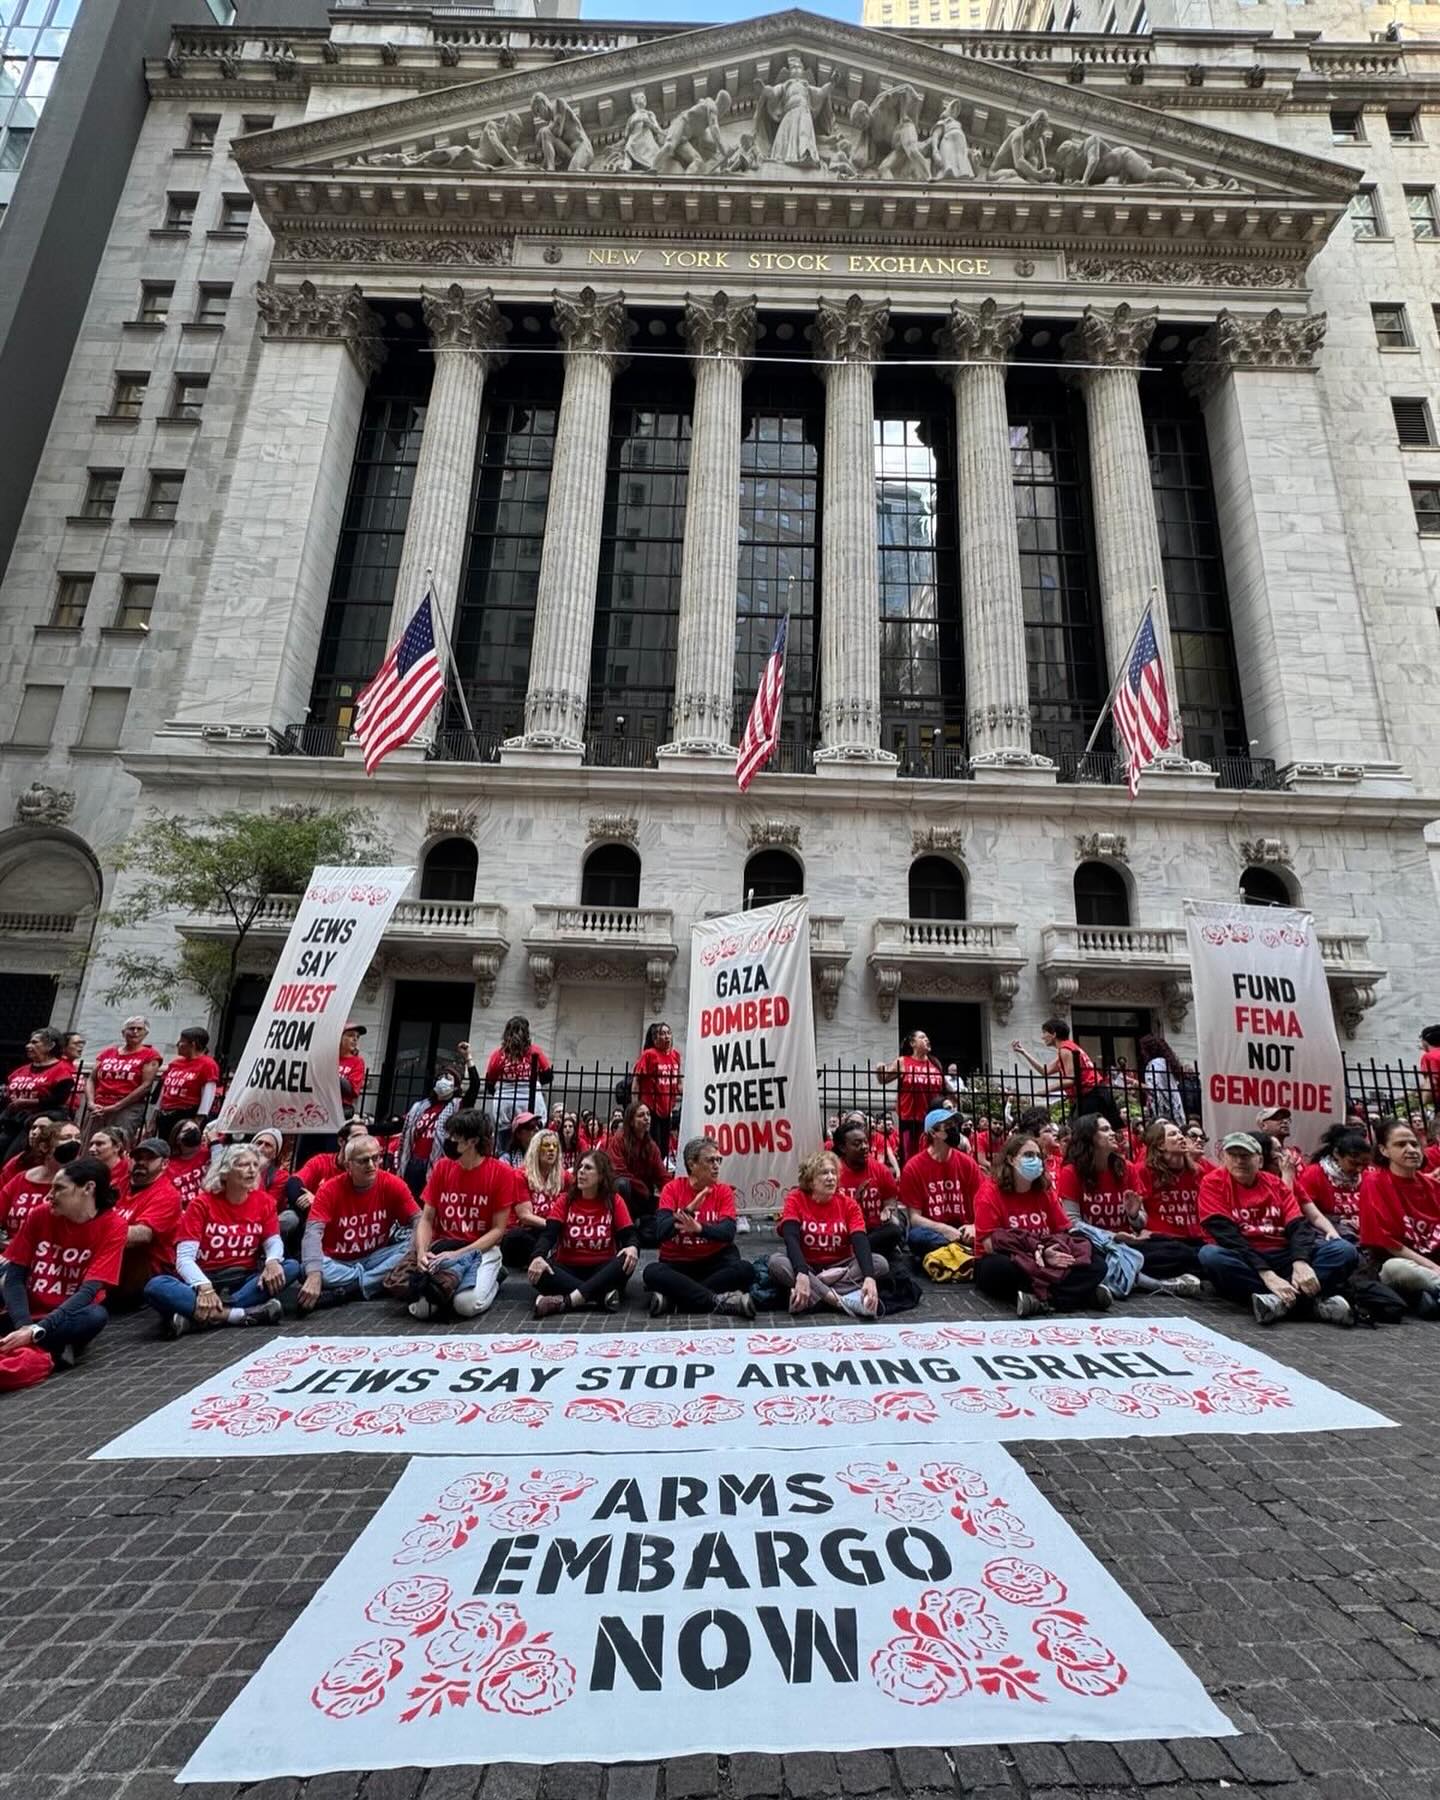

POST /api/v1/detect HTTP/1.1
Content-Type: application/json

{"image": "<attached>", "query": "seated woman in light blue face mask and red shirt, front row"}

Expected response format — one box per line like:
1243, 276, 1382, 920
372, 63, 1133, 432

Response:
976, 1132, 1111, 1319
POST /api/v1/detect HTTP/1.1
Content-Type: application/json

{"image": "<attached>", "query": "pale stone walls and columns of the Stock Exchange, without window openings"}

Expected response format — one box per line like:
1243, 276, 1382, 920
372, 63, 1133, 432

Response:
0, 14, 1440, 1087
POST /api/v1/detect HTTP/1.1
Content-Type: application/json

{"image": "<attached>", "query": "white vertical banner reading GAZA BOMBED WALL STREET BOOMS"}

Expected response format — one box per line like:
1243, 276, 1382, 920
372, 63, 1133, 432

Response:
680, 898, 821, 1211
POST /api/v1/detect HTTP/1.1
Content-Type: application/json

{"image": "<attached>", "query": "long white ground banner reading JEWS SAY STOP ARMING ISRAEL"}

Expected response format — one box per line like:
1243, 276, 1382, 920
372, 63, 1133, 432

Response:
95, 1318, 1391, 1458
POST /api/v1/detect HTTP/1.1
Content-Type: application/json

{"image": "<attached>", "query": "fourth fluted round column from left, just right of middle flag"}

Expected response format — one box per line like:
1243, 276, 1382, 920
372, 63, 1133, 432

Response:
814, 293, 895, 769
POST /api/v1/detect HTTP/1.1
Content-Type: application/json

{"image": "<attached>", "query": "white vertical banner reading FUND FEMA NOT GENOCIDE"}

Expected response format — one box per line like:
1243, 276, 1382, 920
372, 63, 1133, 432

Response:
1184, 900, 1345, 1154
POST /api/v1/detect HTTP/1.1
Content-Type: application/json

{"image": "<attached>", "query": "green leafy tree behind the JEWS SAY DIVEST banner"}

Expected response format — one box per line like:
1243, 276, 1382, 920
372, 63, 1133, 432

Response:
97, 806, 387, 1046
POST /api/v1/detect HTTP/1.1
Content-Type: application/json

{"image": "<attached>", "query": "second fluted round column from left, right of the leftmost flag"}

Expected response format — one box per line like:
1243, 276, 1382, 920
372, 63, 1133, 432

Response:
506, 288, 628, 754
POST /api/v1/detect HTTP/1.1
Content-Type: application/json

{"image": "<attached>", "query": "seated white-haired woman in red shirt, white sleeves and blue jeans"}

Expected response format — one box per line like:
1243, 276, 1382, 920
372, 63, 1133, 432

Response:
146, 1143, 301, 1337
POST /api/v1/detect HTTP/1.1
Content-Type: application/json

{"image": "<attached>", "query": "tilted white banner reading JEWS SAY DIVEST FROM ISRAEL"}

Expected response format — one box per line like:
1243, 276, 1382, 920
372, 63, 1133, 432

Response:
220, 864, 416, 1136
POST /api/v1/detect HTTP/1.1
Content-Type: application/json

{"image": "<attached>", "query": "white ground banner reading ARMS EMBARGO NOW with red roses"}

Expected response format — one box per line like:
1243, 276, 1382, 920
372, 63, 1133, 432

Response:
180, 1445, 1233, 1784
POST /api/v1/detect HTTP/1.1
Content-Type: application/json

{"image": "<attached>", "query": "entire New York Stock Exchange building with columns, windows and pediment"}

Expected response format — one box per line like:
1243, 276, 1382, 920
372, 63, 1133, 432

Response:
0, 0, 1440, 1107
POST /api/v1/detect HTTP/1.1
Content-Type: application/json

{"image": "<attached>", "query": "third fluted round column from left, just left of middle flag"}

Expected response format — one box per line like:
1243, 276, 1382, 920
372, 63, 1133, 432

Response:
661, 293, 756, 756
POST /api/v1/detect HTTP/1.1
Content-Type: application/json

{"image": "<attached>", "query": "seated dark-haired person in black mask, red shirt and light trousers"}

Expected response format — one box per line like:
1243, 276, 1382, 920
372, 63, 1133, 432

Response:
399, 1107, 526, 1319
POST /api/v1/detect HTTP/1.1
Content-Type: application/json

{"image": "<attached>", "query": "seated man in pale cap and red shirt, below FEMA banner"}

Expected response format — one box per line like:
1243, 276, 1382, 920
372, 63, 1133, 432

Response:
1199, 1132, 1359, 1325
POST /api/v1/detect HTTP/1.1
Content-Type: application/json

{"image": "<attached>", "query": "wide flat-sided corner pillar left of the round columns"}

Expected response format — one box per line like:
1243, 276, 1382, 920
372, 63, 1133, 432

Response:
160, 281, 385, 749
